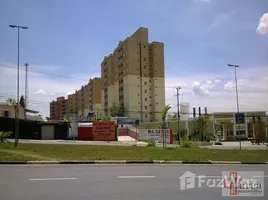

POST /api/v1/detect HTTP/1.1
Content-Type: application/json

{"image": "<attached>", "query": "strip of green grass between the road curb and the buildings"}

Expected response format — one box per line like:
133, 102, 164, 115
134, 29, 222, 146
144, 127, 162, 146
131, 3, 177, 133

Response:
0, 143, 268, 162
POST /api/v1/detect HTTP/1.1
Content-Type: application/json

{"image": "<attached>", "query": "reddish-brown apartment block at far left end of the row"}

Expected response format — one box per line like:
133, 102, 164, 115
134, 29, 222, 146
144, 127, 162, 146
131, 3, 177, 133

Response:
50, 97, 68, 120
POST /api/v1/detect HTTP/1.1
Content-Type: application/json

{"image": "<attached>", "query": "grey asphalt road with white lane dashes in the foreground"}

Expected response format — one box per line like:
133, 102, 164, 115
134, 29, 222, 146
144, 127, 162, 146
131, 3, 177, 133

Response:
0, 165, 268, 200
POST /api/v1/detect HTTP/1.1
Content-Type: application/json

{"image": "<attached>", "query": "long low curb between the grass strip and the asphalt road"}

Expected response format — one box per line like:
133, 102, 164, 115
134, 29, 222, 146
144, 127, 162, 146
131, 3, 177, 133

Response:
0, 160, 268, 165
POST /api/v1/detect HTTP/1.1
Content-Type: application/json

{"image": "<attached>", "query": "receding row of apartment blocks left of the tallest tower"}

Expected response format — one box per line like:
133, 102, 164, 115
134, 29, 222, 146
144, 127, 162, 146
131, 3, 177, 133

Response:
50, 77, 102, 120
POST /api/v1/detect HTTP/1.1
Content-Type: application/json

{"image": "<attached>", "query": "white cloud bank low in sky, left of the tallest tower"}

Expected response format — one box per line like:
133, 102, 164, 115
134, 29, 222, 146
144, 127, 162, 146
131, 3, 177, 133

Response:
0, 64, 100, 116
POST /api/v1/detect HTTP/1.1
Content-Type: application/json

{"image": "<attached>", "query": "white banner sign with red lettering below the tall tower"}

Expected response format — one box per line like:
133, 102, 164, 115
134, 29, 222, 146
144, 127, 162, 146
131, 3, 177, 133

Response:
138, 129, 173, 144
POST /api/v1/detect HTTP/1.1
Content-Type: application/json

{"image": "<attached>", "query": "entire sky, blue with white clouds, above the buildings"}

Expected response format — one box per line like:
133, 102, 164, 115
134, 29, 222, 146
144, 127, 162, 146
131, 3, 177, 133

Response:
0, 0, 268, 116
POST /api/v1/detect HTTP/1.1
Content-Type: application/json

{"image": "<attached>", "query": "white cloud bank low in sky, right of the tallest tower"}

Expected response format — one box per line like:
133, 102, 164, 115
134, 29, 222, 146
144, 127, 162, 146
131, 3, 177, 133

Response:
166, 66, 268, 112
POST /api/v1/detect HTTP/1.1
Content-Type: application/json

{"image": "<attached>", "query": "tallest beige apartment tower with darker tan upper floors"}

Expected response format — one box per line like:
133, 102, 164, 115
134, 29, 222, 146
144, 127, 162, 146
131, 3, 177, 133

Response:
101, 27, 165, 122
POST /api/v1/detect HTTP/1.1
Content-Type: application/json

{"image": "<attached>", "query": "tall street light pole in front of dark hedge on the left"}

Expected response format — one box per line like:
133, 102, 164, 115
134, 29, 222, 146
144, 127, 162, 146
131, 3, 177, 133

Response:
9, 25, 28, 147
